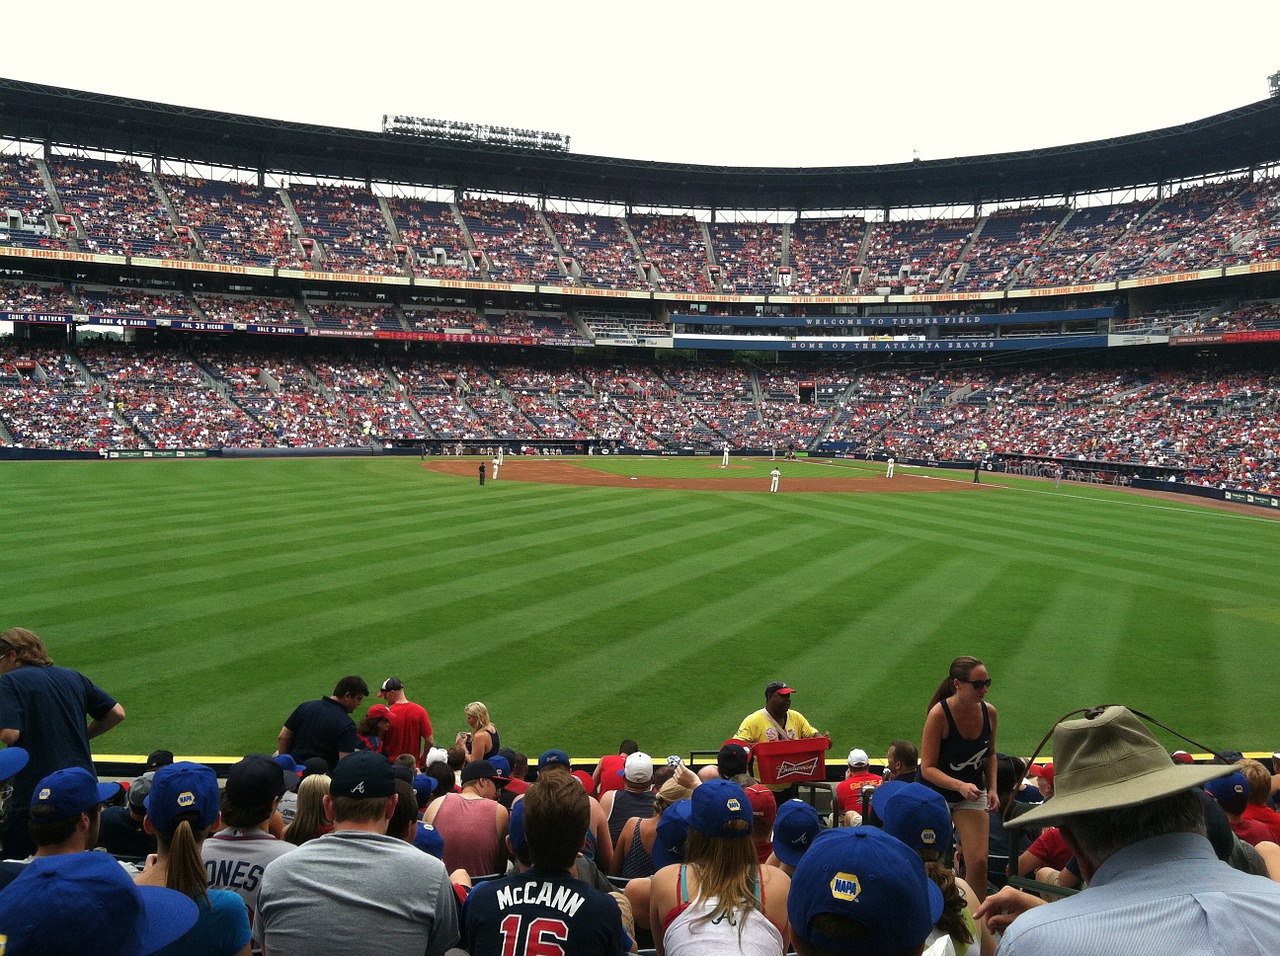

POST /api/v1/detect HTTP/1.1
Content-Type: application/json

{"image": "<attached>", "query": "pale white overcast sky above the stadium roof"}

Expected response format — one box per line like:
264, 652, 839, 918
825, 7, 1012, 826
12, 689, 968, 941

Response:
0, 0, 1280, 166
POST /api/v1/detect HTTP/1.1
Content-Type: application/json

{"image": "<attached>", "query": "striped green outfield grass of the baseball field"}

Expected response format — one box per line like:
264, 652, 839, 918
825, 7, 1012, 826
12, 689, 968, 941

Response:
0, 457, 1280, 756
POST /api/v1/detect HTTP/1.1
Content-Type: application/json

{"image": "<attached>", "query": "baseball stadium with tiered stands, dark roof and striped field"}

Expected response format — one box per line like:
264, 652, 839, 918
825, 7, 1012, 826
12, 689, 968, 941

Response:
0, 72, 1280, 813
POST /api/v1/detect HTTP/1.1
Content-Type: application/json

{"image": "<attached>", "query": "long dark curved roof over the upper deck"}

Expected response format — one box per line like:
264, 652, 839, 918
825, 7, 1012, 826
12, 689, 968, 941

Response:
0, 78, 1280, 210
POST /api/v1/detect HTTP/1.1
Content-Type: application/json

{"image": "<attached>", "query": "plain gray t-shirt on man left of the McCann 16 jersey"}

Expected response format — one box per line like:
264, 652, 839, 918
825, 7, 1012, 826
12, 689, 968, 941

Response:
257, 829, 458, 956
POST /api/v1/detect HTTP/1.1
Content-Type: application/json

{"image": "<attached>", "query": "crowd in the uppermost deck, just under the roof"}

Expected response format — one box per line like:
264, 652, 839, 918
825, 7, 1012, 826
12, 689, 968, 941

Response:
0, 156, 1280, 294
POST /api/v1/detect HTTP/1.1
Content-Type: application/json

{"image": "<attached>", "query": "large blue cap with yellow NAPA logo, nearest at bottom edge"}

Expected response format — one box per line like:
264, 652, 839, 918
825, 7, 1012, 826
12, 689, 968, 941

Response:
787, 827, 942, 956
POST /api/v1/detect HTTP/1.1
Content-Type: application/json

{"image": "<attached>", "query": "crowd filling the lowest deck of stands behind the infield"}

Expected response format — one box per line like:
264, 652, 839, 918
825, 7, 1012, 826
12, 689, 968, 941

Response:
0, 342, 1280, 491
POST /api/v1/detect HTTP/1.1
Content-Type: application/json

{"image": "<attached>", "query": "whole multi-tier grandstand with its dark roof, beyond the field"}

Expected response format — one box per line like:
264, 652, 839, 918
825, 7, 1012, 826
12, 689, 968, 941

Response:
0, 81, 1280, 493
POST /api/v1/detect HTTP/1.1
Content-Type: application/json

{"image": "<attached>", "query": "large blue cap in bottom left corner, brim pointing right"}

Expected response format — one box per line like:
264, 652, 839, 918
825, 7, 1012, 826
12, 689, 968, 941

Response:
0, 851, 200, 956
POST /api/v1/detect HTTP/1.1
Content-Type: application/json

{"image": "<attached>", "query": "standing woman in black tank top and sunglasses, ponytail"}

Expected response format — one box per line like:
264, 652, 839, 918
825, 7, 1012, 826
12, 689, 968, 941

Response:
920, 657, 998, 898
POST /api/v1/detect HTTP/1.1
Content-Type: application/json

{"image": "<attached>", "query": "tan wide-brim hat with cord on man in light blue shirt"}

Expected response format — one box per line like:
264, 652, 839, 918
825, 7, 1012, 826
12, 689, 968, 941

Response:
1005, 706, 1236, 828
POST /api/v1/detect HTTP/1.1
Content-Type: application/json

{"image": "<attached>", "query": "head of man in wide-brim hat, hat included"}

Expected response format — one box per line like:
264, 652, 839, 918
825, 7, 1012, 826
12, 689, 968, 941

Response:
1005, 706, 1233, 879
